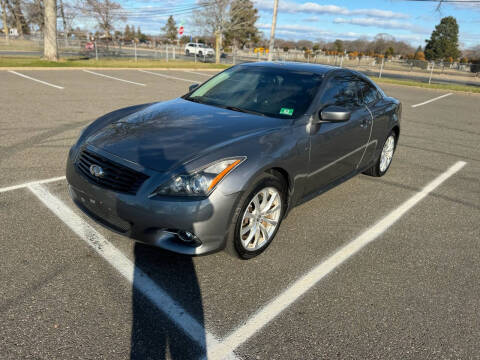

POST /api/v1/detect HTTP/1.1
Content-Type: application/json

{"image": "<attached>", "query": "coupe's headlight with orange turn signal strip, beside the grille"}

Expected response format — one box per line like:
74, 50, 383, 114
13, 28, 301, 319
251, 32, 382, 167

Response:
150, 157, 246, 197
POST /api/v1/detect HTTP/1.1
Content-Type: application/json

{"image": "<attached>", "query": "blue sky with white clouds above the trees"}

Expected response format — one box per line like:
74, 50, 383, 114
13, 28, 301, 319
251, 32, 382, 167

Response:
113, 0, 480, 48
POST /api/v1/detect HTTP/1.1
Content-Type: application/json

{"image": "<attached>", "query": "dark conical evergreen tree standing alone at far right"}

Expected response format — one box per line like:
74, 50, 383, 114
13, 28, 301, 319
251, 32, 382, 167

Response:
425, 16, 461, 60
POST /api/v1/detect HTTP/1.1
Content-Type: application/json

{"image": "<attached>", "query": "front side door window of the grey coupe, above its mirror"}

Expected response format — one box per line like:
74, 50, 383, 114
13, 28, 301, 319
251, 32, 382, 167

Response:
321, 73, 359, 109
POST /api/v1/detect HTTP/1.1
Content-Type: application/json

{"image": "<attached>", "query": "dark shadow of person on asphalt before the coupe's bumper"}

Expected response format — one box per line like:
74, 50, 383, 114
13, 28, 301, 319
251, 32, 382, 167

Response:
130, 243, 206, 360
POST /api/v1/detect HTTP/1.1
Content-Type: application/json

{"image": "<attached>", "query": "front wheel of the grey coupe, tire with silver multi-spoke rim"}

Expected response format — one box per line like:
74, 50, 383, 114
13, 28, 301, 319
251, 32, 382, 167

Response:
228, 173, 287, 259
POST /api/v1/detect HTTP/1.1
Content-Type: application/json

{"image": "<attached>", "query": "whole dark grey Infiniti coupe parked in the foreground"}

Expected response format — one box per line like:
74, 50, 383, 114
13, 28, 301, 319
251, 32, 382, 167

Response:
67, 63, 402, 259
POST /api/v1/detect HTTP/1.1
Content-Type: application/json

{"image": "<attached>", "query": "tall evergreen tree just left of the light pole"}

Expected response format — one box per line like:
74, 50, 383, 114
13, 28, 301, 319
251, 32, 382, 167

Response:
224, 0, 260, 48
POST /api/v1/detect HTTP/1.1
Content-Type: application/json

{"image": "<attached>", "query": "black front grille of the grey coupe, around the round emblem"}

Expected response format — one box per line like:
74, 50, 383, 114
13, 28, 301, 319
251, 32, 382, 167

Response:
75, 149, 148, 194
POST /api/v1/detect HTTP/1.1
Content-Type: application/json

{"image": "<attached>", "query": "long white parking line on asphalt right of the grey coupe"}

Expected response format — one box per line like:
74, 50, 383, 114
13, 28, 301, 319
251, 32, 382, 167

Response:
208, 161, 466, 359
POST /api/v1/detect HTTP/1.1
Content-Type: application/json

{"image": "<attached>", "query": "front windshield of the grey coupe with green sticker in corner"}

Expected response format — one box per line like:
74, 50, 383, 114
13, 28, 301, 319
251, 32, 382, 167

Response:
184, 66, 322, 119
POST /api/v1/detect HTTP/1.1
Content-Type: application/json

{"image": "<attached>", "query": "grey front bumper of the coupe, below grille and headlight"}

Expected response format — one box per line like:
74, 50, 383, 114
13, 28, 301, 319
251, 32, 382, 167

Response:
67, 152, 240, 255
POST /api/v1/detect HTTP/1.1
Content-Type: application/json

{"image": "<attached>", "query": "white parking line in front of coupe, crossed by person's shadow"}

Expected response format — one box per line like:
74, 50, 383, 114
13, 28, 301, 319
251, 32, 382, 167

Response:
28, 184, 236, 359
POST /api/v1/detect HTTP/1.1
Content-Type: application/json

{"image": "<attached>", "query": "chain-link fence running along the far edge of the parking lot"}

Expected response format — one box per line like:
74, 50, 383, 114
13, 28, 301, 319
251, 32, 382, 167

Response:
0, 36, 480, 86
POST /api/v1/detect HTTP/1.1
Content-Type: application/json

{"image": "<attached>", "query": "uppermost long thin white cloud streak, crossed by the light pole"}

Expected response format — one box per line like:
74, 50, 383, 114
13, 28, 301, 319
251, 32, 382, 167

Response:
254, 0, 409, 19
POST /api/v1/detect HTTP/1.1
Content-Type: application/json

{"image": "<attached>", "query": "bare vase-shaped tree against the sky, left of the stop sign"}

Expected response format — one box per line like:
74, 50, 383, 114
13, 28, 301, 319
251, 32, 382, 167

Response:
83, 0, 126, 39
